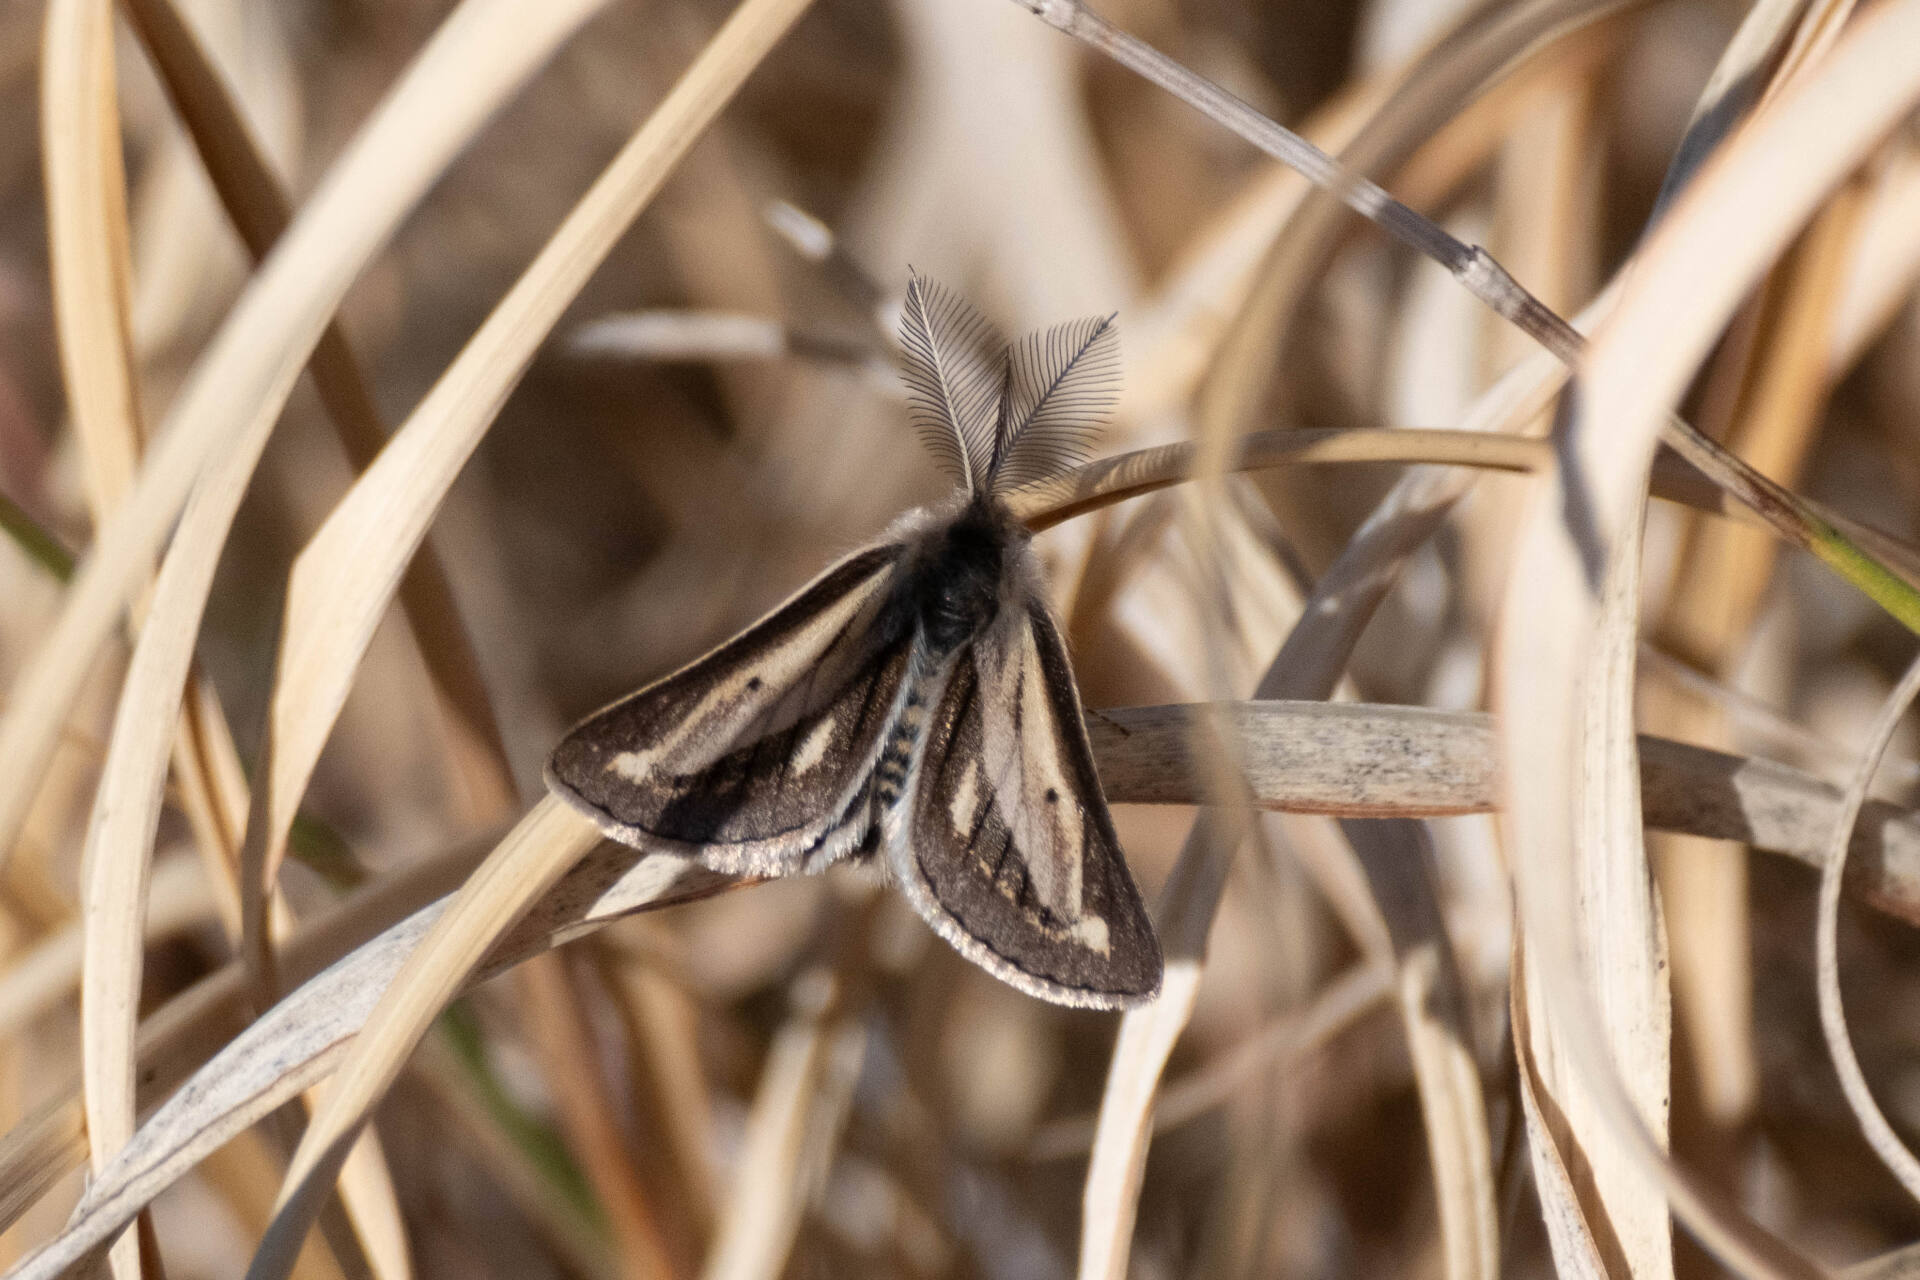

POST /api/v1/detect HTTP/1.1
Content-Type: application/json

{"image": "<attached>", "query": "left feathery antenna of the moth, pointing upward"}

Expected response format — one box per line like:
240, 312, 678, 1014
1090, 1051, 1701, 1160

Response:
900, 269, 1008, 493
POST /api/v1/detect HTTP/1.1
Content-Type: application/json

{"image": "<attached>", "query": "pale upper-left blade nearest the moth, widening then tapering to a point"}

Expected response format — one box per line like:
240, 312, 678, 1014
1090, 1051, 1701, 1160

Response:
242, 0, 810, 982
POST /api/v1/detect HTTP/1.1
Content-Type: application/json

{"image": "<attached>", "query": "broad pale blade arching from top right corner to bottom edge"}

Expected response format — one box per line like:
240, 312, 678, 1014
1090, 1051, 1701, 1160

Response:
1500, 4, 1920, 1274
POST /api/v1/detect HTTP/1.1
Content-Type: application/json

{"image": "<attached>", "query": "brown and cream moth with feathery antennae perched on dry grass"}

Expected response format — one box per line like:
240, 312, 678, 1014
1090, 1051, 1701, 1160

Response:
547, 274, 1162, 1009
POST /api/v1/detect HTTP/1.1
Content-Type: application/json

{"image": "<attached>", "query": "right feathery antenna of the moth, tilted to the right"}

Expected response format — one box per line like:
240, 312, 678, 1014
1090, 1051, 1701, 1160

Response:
991, 313, 1119, 493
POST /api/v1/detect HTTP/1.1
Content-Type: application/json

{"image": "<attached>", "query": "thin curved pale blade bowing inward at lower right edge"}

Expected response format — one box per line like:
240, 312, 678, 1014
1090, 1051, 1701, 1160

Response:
1814, 658, 1920, 1199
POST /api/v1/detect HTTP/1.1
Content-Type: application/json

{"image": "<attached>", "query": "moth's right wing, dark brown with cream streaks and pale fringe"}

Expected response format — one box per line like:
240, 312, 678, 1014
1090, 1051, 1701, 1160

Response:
887, 601, 1162, 1009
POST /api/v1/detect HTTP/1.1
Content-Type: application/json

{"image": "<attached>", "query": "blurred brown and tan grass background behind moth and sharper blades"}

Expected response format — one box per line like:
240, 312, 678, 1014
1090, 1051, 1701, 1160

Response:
0, 0, 1920, 1280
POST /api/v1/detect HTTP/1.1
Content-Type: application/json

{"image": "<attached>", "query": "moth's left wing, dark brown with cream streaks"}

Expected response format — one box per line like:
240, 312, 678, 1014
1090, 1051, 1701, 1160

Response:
547, 545, 912, 875
